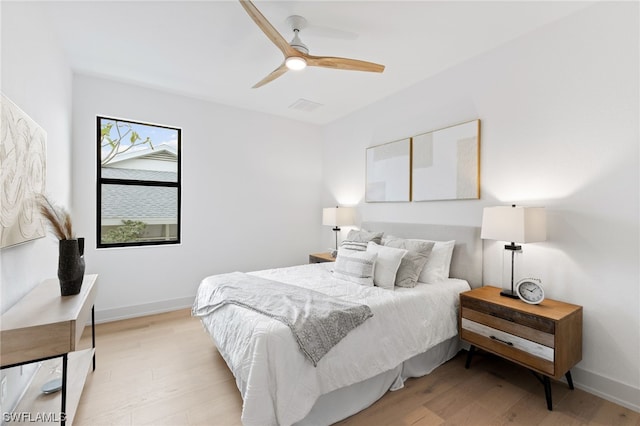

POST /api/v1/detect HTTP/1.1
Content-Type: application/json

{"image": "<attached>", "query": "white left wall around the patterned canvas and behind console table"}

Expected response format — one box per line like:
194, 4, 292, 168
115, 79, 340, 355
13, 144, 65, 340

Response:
0, 2, 71, 412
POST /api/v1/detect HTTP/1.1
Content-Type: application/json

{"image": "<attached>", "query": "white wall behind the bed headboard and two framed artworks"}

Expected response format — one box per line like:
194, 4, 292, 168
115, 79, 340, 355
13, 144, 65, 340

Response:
323, 2, 640, 410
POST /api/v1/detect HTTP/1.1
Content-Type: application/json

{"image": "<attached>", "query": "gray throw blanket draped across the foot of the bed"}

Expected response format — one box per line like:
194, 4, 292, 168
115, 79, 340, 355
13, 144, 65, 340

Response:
192, 272, 373, 367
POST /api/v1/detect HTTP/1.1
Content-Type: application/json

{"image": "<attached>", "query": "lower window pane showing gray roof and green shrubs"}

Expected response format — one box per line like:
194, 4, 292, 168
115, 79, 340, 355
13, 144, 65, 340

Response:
100, 184, 178, 244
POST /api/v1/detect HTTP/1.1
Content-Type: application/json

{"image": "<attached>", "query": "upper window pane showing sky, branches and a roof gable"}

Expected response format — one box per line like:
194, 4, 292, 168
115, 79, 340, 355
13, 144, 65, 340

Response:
98, 117, 179, 182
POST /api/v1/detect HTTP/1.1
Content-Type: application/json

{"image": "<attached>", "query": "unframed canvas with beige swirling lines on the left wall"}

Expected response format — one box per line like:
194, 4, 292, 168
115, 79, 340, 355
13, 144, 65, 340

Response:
0, 94, 47, 248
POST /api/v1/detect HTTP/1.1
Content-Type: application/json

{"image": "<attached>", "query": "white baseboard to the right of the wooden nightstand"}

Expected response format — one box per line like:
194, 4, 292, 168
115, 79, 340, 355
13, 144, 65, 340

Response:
571, 367, 640, 413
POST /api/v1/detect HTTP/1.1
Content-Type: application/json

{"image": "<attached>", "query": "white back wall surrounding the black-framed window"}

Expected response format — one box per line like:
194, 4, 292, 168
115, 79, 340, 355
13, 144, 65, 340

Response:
73, 75, 322, 320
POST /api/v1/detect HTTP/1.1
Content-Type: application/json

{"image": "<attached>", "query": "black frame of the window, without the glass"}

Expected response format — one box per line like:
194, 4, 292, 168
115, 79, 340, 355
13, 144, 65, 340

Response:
96, 115, 182, 249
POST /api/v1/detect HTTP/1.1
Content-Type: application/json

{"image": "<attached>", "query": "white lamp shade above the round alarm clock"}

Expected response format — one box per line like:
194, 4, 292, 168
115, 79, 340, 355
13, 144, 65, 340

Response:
480, 206, 547, 243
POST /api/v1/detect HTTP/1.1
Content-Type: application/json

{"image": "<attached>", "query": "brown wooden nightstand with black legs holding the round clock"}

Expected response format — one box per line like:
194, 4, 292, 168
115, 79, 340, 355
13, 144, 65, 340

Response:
458, 287, 582, 410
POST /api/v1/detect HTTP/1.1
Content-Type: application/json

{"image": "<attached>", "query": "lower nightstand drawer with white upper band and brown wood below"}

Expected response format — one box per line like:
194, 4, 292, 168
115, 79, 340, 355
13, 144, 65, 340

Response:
460, 318, 555, 376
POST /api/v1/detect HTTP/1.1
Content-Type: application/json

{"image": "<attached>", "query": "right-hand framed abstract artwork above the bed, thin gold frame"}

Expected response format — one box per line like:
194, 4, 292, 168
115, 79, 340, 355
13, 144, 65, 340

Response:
411, 120, 480, 201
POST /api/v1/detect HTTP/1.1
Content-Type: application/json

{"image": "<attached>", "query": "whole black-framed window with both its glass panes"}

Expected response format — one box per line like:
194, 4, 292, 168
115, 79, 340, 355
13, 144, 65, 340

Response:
97, 117, 181, 248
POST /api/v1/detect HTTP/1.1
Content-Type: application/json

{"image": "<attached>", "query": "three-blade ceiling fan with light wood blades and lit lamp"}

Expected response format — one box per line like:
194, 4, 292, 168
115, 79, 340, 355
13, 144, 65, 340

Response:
240, 0, 384, 89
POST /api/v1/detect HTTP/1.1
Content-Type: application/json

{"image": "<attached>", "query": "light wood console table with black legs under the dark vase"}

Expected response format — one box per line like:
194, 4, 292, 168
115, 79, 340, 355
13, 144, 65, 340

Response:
0, 275, 98, 425
